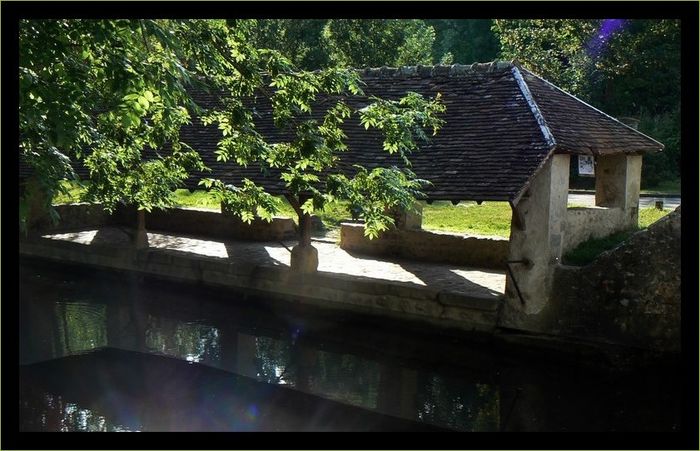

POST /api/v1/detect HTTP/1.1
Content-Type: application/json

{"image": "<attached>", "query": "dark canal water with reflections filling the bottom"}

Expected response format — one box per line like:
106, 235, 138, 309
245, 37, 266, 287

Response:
19, 260, 682, 431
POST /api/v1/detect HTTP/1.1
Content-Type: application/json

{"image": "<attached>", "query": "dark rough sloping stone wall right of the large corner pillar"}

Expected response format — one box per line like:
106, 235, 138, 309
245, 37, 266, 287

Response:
548, 207, 680, 352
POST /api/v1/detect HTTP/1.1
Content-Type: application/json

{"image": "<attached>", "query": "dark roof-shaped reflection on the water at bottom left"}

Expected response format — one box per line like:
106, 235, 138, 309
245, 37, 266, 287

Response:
20, 348, 452, 431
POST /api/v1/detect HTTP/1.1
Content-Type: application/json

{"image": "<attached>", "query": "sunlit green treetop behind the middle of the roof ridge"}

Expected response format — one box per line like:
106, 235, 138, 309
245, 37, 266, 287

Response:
323, 19, 435, 67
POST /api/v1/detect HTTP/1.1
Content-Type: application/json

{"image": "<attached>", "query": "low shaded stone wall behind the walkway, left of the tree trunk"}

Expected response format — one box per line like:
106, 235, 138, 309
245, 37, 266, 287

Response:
39, 204, 296, 241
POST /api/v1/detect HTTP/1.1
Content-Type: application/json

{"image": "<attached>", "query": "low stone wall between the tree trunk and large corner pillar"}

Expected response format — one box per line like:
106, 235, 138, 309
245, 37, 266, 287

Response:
340, 223, 508, 269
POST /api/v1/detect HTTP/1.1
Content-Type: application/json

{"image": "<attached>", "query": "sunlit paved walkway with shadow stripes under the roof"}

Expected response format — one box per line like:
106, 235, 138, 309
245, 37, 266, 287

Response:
44, 227, 505, 298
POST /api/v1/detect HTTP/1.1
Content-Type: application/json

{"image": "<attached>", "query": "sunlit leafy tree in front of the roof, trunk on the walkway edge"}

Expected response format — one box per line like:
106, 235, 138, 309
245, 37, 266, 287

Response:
201, 30, 444, 272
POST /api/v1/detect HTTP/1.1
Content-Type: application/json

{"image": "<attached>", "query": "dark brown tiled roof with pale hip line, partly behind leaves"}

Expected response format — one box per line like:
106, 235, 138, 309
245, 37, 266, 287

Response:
20, 62, 663, 200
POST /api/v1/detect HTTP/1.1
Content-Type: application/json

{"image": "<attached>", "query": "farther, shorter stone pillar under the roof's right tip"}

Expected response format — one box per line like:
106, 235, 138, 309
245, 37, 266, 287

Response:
595, 154, 642, 228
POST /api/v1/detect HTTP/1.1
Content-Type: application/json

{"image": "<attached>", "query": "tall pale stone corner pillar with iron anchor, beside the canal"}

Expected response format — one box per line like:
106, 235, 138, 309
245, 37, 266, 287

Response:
500, 155, 569, 330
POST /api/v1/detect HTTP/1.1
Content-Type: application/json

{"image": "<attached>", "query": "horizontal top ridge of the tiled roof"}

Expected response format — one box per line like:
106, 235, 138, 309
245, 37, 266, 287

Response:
355, 60, 517, 78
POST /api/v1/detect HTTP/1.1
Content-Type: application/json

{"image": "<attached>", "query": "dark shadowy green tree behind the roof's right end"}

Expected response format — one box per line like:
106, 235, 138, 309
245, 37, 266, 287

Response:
592, 20, 681, 187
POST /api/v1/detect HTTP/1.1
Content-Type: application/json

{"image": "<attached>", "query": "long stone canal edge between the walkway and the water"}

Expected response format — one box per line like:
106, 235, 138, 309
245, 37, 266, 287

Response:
20, 238, 500, 332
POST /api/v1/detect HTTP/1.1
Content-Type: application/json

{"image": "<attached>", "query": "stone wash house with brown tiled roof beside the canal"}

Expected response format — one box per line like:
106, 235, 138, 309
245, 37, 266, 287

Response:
172, 61, 663, 330
